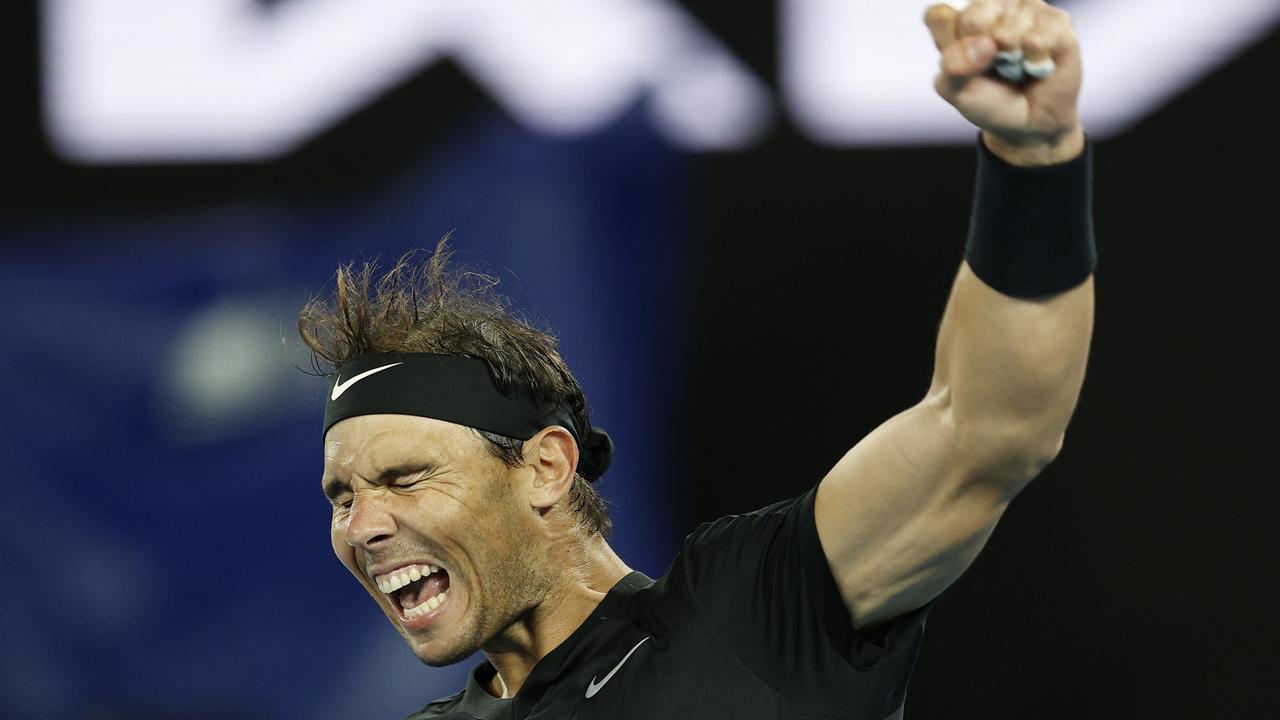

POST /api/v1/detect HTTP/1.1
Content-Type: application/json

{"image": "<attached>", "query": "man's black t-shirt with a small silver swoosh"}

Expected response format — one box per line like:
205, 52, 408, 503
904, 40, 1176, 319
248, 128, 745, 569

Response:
410, 488, 932, 720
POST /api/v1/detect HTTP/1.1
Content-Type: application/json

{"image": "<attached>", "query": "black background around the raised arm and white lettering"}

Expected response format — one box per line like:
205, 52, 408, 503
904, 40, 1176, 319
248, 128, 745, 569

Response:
3, 3, 1280, 720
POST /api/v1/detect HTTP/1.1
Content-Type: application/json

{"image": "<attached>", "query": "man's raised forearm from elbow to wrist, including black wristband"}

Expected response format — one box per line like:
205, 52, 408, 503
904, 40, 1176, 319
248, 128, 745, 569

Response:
931, 131, 1093, 474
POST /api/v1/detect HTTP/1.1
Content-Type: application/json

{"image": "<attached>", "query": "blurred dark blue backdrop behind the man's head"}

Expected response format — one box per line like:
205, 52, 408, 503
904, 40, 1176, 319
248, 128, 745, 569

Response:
0, 113, 687, 719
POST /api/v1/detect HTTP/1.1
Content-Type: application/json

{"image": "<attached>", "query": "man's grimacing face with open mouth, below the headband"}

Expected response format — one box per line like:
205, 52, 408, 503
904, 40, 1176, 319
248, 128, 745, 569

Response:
323, 415, 550, 665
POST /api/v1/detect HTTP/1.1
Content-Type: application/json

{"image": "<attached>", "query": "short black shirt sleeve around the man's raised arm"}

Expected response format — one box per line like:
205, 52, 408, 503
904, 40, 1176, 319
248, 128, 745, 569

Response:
671, 486, 933, 719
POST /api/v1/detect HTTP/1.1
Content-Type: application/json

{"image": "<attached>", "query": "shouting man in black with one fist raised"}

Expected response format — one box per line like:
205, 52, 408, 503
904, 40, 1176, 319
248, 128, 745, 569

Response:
300, 0, 1096, 720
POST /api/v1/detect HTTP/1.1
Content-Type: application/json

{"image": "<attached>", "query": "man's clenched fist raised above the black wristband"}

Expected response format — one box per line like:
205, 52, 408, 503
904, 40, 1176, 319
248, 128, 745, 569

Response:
924, 0, 1084, 165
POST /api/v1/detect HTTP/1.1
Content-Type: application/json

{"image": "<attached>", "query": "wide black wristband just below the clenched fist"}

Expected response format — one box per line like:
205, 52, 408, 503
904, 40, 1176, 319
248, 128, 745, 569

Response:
964, 136, 1098, 297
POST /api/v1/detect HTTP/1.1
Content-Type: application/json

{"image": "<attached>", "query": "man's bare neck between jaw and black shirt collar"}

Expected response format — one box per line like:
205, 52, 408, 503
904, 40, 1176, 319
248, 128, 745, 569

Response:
484, 533, 631, 697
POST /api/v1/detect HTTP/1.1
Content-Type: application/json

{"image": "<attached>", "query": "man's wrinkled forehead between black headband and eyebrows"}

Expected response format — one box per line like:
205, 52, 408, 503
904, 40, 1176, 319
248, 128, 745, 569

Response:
324, 415, 481, 475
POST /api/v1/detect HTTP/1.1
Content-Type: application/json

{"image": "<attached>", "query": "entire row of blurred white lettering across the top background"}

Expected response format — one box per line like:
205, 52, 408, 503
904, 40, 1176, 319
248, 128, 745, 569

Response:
42, 0, 1280, 163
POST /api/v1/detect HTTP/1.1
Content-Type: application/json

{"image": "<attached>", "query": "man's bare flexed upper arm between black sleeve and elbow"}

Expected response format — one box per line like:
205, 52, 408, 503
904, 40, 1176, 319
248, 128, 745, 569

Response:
814, 389, 1033, 629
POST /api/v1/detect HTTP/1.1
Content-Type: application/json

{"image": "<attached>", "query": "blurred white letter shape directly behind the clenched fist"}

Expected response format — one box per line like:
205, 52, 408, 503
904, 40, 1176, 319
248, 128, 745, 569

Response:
780, 0, 1280, 145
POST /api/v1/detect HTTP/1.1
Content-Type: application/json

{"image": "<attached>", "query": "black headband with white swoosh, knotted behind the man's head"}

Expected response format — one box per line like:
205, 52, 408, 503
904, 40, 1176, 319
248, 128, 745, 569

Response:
324, 352, 613, 480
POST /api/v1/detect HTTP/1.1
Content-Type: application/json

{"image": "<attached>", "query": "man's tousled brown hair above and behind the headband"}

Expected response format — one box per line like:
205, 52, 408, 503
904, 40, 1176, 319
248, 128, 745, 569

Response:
298, 236, 613, 537
